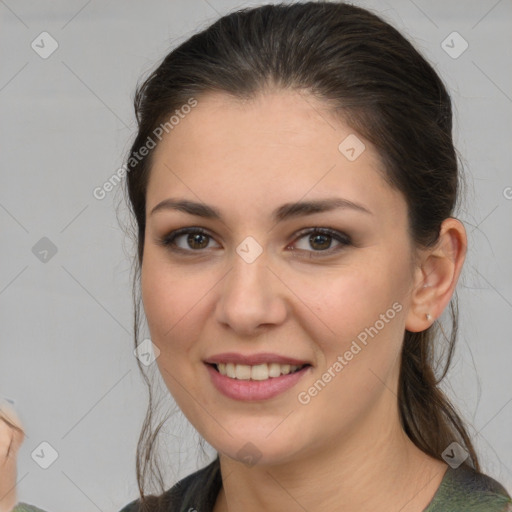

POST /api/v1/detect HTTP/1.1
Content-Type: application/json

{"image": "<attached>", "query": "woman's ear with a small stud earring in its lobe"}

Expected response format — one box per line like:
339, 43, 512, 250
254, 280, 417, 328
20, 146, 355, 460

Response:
405, 217, 467, 332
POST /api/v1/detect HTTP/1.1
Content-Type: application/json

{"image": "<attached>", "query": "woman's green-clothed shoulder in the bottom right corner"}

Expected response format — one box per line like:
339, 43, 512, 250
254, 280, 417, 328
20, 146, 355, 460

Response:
424, 464, 512, 512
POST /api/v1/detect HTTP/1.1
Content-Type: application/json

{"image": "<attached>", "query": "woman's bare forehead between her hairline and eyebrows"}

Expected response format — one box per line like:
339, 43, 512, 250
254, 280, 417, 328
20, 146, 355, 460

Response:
147, 91, 404, 224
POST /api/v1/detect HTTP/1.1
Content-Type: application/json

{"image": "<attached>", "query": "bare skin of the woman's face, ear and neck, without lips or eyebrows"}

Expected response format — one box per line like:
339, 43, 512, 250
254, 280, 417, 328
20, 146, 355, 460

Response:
141, 90, 466, 512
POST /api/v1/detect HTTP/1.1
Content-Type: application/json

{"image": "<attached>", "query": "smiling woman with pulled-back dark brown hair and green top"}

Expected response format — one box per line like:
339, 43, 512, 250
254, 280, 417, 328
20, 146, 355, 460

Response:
4, 2, 512, 512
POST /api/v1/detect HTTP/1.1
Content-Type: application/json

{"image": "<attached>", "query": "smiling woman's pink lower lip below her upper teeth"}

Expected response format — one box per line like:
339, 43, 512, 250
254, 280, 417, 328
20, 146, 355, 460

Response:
206, 364, 311, 401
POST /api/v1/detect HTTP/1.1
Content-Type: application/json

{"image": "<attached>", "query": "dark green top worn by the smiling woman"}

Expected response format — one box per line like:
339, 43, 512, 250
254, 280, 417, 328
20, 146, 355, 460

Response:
12, 457, 512, 512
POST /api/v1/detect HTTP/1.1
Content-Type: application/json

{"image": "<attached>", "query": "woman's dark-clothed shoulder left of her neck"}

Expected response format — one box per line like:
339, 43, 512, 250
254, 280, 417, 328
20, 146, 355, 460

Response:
119, 457, 222, 512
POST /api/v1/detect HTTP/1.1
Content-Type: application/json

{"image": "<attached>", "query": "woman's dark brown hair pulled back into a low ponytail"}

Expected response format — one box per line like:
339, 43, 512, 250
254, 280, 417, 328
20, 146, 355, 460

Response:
121, 2, 480, 510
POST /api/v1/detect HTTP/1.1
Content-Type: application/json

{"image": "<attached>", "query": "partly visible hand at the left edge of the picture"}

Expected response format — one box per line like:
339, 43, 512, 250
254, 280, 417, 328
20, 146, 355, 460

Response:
0, 400, 25, 512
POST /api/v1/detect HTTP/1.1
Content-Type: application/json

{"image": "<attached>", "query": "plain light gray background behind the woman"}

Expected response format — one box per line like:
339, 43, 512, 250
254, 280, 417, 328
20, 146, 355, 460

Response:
0, 0, 512, 512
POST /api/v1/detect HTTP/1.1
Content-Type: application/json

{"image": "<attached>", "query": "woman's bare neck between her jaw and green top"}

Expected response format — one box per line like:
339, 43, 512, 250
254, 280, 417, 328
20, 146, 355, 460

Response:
214, 396, 447, 512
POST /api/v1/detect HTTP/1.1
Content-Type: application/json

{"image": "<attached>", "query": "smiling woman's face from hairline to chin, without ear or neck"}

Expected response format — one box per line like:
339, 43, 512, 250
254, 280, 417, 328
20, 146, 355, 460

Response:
141, 91, 420, 464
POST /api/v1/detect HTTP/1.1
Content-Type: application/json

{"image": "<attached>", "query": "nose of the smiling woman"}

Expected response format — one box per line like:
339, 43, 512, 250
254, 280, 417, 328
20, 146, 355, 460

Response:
215, 244, 289, 337
